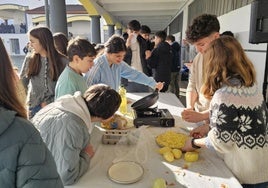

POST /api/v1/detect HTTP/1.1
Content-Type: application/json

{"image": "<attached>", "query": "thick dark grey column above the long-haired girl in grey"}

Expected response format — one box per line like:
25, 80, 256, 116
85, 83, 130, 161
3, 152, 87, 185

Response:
49, 0, 68, 36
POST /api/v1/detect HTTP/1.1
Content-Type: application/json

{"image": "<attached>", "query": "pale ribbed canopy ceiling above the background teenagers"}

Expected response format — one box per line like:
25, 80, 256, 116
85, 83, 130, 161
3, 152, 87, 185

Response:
95, 0, 192, 33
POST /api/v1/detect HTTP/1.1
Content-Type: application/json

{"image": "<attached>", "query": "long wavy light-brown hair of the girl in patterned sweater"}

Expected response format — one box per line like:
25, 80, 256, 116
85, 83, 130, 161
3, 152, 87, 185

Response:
201, 36, 256, 98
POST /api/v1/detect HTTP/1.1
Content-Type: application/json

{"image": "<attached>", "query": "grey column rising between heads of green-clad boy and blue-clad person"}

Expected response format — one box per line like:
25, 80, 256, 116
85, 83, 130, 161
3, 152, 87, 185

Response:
90, 15, 101, 44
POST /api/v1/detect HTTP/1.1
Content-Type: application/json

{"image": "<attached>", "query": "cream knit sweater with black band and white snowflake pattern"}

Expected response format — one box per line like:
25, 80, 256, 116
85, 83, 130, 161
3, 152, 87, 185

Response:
208, 80, 268, 184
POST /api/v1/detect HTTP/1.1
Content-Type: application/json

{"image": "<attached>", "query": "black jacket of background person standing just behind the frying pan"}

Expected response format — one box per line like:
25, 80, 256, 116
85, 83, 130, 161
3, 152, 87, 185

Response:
147, 42, 172, 92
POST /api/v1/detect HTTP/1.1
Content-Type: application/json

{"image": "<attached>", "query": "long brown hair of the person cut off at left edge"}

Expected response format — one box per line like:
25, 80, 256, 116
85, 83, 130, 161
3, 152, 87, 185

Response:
0, 38, 27, 118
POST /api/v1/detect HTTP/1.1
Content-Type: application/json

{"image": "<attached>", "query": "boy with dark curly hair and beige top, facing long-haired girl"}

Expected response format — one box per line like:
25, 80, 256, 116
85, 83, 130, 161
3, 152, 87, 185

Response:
182, 14, 220, 137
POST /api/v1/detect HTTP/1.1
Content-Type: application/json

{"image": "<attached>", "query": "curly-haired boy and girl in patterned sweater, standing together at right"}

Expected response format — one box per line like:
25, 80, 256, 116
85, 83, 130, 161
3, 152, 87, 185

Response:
181, 14, 268, 188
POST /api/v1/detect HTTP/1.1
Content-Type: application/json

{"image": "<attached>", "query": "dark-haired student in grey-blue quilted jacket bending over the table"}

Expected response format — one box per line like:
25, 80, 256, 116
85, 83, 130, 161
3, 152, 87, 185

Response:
32, 84, 121, 185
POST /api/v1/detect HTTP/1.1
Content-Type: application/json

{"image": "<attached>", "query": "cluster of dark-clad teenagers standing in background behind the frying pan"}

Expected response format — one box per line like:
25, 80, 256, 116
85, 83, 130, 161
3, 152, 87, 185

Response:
122, 20, 180, 94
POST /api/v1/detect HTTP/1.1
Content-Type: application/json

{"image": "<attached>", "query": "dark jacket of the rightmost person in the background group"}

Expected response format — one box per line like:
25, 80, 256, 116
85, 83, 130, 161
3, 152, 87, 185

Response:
171, 42, 181, 72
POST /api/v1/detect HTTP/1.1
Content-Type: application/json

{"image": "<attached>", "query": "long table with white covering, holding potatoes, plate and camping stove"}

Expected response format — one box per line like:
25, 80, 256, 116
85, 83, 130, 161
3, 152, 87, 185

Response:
65, 93, 242, 188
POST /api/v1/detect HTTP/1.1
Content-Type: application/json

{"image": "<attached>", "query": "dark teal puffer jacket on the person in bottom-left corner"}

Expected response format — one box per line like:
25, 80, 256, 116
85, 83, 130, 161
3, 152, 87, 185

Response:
0, 107, 63, 188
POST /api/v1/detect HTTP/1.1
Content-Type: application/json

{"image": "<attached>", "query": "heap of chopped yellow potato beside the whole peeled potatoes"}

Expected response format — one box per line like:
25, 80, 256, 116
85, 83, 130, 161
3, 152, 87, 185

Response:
156, 131, 188, 149
